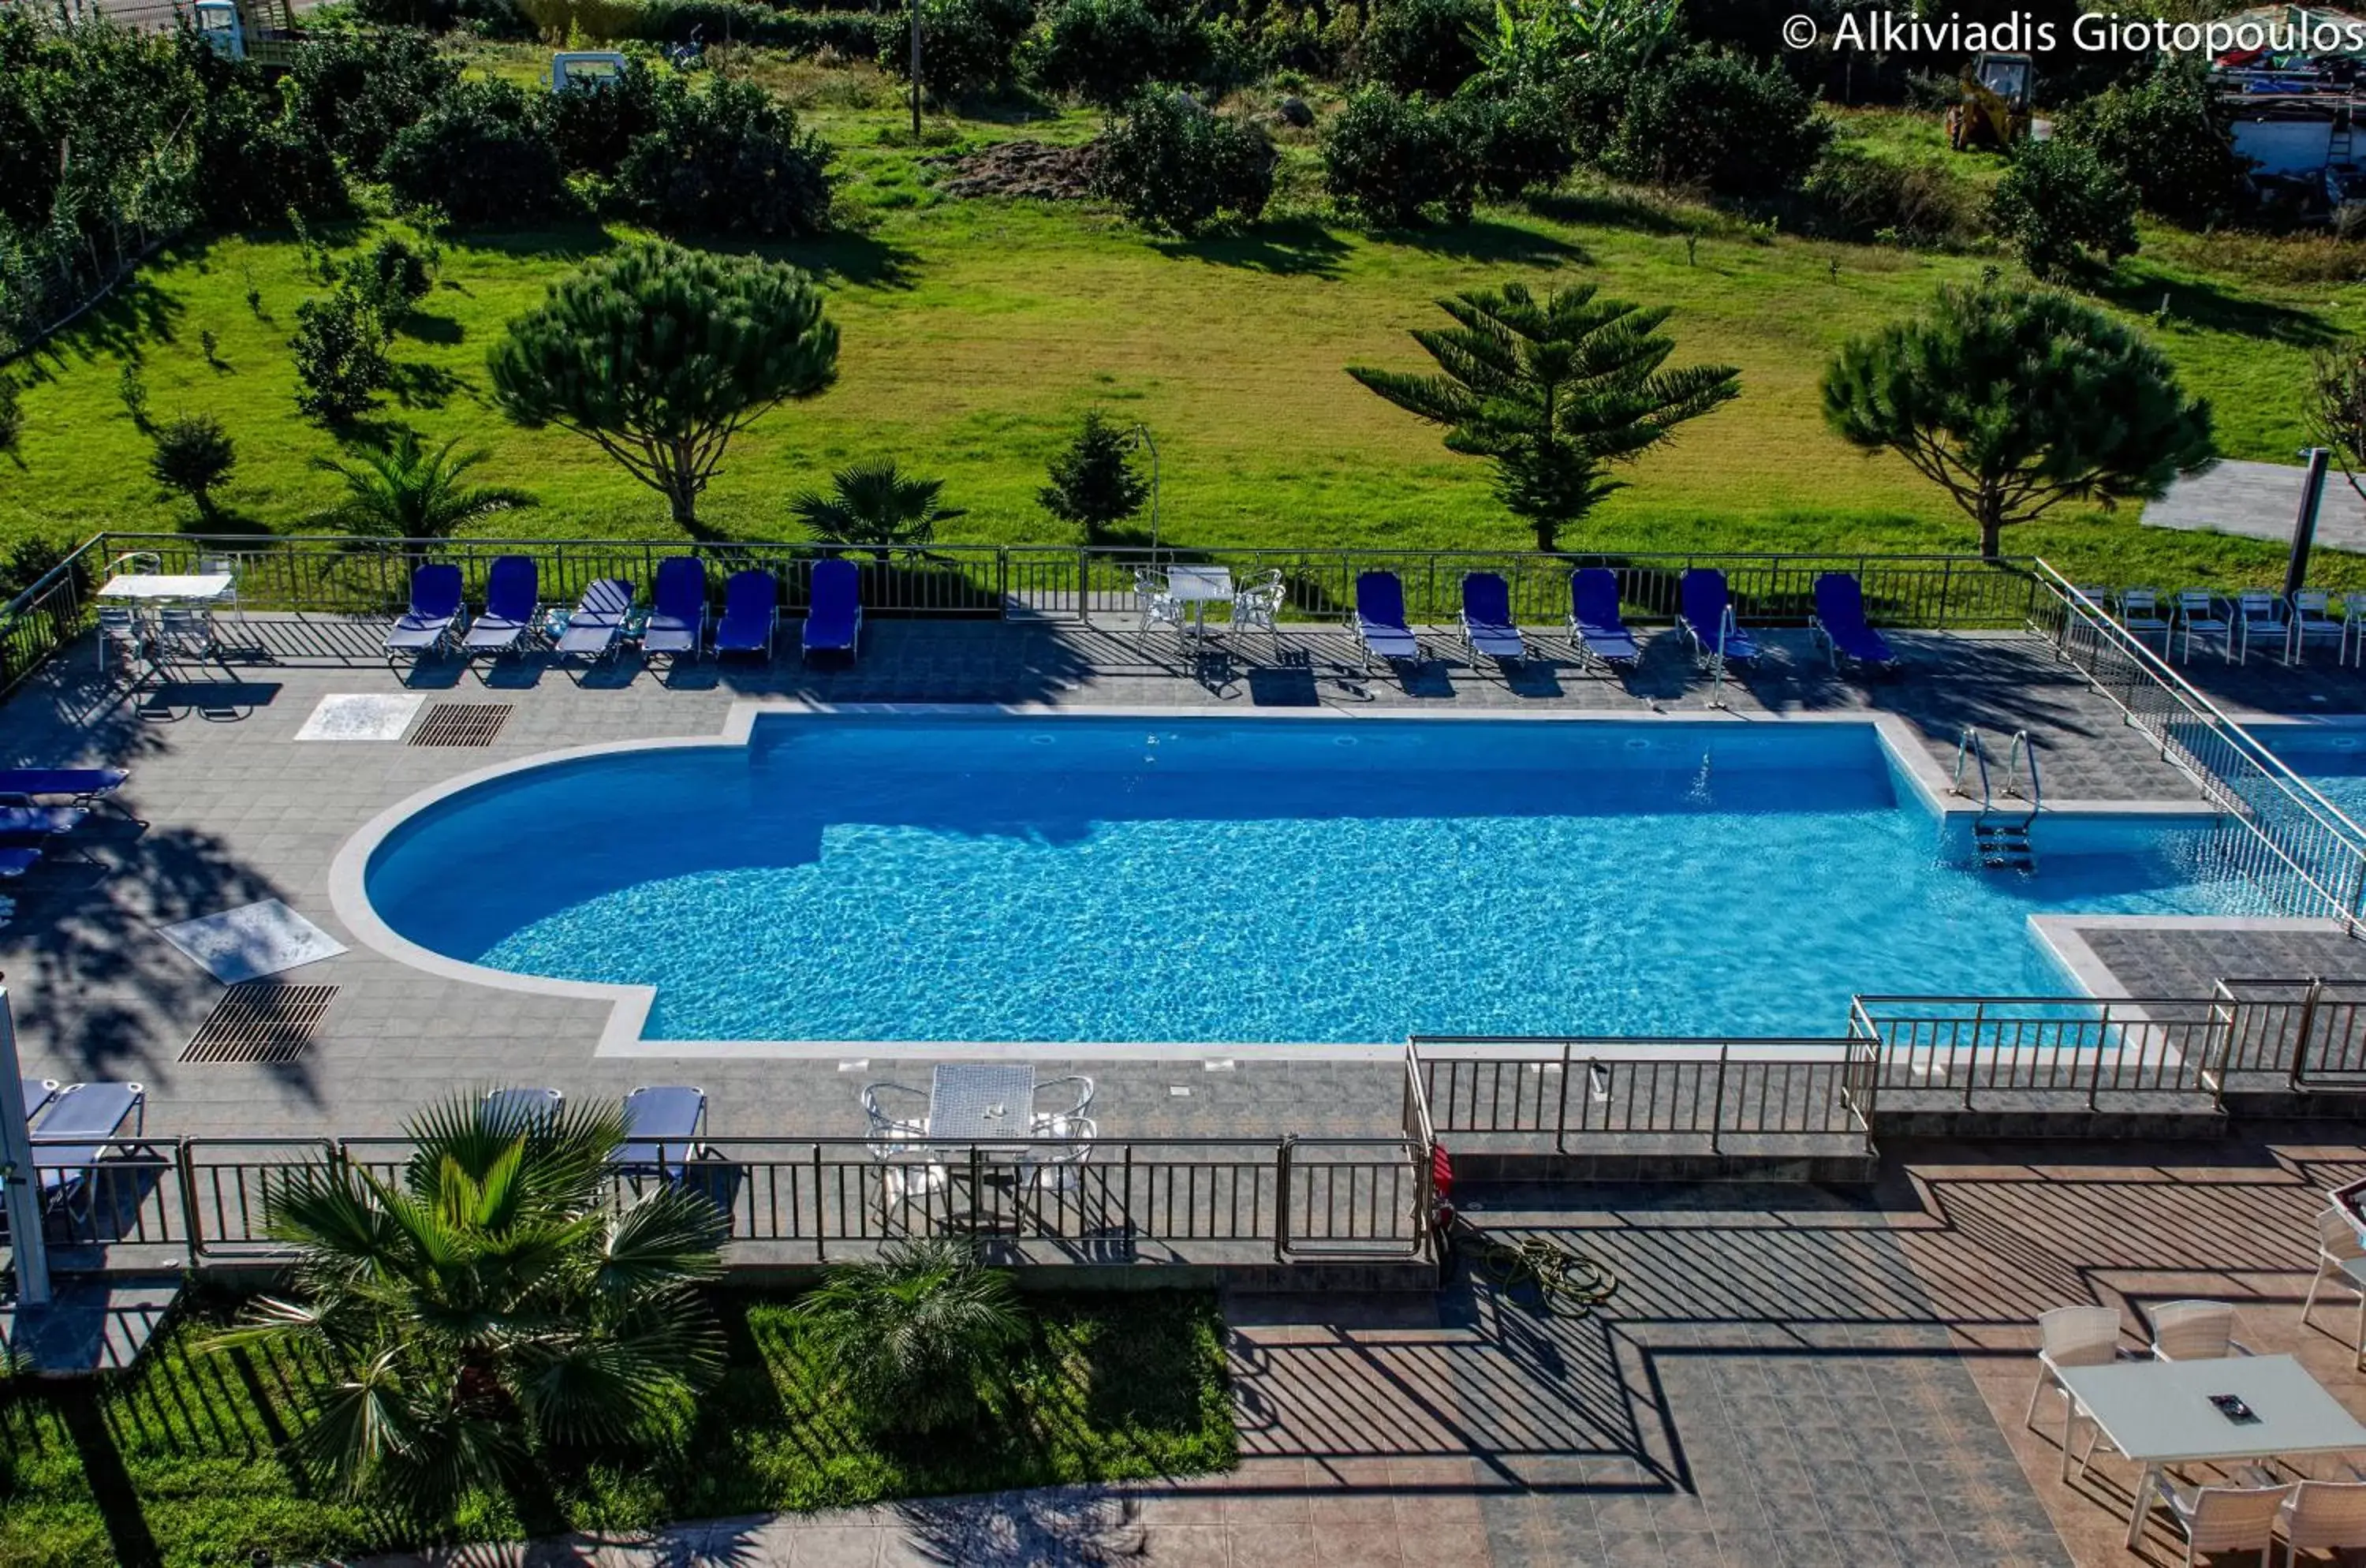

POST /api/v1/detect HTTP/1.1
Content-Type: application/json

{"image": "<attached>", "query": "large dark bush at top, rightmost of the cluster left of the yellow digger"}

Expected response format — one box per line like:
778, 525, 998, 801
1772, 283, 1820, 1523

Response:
1602, 54, 1831, 199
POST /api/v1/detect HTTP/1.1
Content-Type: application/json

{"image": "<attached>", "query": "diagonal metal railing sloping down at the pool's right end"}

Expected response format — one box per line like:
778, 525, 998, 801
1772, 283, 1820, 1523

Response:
2030, 561, 2366, 929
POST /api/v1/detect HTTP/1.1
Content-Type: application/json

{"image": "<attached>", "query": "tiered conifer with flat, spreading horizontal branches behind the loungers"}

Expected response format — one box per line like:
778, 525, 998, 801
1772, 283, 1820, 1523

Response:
1346, 284, 1741, 551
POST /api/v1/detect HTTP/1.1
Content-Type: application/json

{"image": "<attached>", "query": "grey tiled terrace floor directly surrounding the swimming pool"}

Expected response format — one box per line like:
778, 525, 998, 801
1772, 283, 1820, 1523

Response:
0, 618, 2309, 1137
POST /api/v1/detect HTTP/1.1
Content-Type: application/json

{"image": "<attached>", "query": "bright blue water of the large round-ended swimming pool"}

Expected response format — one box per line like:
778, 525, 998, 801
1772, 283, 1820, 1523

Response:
369, 717, 2231, 1040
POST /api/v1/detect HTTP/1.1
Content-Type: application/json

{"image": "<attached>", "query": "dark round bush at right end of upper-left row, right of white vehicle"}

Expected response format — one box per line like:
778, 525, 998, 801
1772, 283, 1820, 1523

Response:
618, 76, 830, 239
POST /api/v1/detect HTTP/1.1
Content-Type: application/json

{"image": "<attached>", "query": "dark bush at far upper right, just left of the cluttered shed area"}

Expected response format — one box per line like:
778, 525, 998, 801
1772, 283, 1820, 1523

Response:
2054, 59, 2245, 227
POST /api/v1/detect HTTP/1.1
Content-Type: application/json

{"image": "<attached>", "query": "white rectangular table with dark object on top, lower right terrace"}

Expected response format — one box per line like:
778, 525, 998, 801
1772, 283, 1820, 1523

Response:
2061, 1355, 2366, 1551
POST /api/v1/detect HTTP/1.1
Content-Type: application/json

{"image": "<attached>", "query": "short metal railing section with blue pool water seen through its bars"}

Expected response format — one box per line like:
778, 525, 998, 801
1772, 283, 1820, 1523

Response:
1848, 995, 2236, 1111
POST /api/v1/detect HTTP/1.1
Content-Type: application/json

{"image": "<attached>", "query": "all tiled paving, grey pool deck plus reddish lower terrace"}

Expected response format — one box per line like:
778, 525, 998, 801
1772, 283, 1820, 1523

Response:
13, 620, 2366, 1568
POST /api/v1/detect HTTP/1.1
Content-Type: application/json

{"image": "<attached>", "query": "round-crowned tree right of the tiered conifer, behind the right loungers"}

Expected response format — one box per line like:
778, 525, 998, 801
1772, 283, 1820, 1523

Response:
1824, 286, 2212, 556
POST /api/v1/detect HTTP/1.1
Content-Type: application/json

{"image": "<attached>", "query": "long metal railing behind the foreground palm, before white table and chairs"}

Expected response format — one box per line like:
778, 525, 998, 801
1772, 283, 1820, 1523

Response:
18, 1137, 1434, 1267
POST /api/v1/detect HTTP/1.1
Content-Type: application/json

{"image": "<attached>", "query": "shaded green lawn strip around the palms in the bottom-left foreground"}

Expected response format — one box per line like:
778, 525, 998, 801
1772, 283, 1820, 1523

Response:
0, 1291, 1235, 1568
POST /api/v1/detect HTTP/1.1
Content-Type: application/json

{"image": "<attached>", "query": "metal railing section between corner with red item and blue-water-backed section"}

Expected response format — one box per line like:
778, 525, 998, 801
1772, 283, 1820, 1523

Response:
1405, 1036, 1876, 1154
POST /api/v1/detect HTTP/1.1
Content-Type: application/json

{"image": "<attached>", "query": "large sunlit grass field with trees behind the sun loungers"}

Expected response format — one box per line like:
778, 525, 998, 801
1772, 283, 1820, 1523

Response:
0, 72, 2366, 587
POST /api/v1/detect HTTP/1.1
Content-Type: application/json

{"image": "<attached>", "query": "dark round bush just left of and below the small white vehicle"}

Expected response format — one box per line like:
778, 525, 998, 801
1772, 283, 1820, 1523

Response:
383, 83, 565, 222
